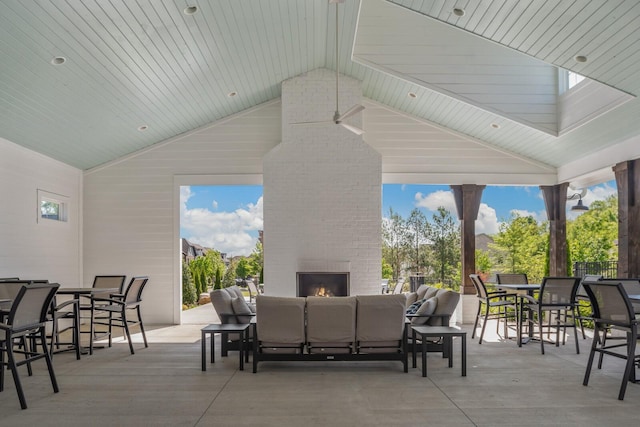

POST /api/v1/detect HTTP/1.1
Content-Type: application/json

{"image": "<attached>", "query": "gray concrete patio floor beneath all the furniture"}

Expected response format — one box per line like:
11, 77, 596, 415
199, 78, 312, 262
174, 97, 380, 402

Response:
0, 306, 640, 427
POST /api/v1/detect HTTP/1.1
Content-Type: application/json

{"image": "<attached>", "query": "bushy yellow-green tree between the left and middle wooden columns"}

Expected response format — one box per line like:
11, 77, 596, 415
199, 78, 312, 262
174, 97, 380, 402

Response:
490, 215, 549, 282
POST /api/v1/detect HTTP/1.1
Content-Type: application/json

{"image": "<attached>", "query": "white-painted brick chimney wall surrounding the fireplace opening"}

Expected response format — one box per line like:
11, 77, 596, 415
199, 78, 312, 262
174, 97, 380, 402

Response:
263, 69, 382, 296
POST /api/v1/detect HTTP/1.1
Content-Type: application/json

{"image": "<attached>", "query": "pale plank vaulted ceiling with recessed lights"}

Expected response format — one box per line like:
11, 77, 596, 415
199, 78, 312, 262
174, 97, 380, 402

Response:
0, 0, 640, 184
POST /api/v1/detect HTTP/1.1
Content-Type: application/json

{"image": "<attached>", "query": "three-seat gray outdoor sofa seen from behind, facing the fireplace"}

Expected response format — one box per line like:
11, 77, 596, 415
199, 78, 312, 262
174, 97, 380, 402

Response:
253, 295, 408, 373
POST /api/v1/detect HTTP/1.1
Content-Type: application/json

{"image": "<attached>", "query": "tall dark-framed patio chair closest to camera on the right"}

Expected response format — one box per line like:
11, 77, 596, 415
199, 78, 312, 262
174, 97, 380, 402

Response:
582, 281, 640, 400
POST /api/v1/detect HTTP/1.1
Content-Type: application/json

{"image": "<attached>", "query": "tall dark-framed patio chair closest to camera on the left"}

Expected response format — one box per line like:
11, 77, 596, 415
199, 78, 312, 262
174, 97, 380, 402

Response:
0, 283, 60, 409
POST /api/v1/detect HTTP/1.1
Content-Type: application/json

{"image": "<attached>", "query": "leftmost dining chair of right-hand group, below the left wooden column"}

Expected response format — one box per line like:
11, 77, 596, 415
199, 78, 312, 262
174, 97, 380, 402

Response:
469, 274, 517, 344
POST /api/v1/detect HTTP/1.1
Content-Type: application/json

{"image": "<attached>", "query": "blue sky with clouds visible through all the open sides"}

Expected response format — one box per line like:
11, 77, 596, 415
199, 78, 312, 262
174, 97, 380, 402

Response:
180, 181, 616, 256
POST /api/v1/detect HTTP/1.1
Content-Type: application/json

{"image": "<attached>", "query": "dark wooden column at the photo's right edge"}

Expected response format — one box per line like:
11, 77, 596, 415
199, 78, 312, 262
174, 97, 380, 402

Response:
613, 159, 640, 277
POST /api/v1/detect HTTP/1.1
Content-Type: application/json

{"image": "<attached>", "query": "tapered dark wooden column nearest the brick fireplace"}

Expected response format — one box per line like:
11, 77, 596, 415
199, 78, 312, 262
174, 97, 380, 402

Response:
451, 184, 486, 294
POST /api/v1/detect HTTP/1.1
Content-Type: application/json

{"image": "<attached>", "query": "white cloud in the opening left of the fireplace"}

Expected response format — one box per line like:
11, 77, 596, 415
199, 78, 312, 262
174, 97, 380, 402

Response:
180, 187, 263, 256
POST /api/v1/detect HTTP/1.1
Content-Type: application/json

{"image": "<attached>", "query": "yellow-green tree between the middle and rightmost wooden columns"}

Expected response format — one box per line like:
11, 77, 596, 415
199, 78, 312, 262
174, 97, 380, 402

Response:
567, 196, 618, 262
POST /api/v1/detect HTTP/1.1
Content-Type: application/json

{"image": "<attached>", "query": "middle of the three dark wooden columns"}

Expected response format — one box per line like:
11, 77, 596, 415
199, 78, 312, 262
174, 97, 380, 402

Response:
540, 182, 569, 276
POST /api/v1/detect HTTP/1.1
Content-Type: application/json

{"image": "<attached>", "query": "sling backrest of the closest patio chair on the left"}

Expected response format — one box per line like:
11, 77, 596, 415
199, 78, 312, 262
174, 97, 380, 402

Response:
7, 283, 60, 332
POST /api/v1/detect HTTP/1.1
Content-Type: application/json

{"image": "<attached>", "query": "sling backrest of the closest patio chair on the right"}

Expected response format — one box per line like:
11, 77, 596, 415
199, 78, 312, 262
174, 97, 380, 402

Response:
583, 280, 635, 327
